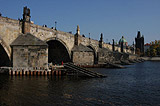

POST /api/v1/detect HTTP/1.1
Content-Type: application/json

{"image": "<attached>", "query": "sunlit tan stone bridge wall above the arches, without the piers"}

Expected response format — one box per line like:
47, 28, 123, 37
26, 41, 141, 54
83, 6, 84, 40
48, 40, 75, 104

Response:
0, 7, 132, 67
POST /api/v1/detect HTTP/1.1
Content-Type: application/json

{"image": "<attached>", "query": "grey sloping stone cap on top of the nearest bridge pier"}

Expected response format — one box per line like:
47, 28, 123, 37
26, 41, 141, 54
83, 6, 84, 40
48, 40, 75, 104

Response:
11, 33, 48, 46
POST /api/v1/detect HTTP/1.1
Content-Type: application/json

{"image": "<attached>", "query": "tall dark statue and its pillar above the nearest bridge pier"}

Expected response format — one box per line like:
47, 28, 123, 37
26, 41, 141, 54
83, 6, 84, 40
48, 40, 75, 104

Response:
22, 7, 31, 34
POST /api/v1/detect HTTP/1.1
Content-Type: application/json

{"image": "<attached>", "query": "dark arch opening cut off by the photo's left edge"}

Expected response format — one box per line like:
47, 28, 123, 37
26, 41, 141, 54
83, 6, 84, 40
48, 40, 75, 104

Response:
0, 44, 11, 67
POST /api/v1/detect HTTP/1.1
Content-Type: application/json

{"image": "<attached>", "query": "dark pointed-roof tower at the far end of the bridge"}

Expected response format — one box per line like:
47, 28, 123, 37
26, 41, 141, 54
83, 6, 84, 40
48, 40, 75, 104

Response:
135, 31, 144, 55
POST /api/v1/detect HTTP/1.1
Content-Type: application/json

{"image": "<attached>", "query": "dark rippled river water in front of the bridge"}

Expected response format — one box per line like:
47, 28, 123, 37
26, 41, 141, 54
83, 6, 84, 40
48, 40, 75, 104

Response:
0, 61, 160, 106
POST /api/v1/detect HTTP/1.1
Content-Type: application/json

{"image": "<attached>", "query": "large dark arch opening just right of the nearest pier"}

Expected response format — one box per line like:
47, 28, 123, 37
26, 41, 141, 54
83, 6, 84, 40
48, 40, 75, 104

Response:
47, 40, 71, 64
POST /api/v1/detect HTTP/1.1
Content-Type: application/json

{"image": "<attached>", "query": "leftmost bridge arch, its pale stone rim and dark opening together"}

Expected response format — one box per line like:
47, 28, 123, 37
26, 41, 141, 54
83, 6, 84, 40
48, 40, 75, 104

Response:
0, 38, 11, 67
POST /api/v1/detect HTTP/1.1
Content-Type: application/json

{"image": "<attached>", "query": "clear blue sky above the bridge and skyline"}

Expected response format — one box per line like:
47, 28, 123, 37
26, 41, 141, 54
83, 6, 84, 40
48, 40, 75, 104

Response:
0, 0, 160, 44
